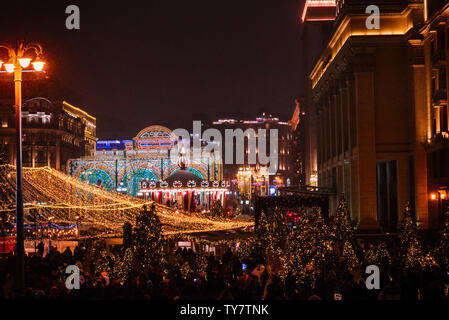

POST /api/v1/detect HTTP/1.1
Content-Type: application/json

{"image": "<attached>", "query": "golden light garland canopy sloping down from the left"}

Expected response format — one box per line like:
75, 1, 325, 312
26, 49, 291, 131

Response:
0, 165, 254, 238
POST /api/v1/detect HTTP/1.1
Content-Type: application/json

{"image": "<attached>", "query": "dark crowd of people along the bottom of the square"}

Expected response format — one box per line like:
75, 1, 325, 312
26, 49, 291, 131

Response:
0, 245, 449, 301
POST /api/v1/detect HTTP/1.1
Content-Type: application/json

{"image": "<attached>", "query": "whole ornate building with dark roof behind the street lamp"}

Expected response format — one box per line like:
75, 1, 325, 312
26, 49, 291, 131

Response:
0, 74, 96, 171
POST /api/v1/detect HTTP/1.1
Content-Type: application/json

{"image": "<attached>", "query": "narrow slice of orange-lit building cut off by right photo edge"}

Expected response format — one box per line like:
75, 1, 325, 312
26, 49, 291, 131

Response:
420, 1, 449, 229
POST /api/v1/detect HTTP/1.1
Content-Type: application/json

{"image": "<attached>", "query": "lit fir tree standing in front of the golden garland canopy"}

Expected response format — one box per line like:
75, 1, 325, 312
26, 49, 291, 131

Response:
134, 204, 164, 270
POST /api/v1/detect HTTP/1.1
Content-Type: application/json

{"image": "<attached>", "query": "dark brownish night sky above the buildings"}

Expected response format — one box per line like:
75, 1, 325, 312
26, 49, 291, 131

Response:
0, 0, 303, 138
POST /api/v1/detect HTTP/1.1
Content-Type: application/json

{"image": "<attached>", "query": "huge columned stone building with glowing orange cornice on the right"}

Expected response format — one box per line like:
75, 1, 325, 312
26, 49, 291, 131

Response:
300, 0, 440, 231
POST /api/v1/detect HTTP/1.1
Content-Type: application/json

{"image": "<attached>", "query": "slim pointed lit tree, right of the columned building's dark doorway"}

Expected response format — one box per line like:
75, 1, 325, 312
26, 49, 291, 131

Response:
399, 202, 424, 269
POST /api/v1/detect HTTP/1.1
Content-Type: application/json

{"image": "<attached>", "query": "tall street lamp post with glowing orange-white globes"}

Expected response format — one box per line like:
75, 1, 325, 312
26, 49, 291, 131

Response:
0, 40, 45, 292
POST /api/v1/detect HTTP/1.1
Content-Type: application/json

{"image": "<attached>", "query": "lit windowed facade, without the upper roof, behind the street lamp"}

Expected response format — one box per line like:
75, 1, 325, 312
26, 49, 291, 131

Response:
0, 97, 96, 171
